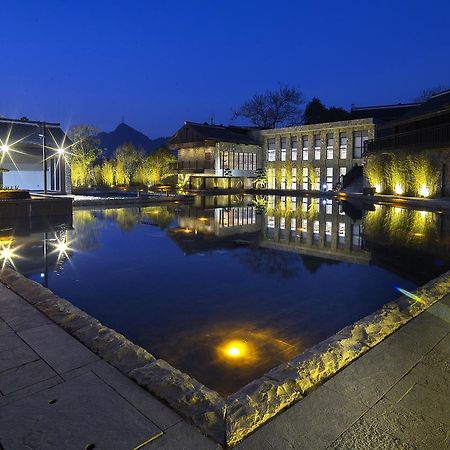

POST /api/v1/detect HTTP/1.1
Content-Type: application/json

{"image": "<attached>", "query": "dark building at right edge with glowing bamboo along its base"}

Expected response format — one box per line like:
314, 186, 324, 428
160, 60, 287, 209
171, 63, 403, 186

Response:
365, 91, 450, 197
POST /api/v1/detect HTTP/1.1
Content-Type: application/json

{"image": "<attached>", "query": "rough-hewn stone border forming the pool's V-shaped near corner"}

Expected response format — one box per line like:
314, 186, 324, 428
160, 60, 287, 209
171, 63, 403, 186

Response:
0, 268, 450, 447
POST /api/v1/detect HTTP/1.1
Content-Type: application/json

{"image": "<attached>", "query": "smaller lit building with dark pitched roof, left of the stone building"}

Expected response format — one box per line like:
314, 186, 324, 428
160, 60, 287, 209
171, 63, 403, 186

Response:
169, 122, 263, 189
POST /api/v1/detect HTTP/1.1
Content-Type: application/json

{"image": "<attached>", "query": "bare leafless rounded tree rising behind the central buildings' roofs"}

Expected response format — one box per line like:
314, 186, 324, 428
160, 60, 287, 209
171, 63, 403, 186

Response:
233, 84, 305, 128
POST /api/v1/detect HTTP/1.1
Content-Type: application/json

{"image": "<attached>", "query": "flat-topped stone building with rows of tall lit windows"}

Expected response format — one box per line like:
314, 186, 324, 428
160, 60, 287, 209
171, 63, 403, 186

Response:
259, 119, 375, 191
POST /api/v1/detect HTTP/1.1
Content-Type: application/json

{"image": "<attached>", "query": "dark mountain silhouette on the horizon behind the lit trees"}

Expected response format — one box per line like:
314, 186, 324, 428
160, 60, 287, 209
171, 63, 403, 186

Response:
97, 123, 169, 158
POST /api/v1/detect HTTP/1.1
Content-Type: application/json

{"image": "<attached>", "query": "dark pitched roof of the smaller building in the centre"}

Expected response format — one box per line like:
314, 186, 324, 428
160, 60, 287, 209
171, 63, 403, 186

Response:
169, 122, 259, 146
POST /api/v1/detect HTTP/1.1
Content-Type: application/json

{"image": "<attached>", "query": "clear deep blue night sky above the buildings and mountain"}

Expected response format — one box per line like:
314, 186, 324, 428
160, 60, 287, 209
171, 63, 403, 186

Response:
0, 0, 450, 138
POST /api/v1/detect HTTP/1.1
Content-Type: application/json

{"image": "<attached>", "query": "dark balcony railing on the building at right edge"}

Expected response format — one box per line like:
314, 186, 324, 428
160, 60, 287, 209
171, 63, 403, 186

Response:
365, 124, 450, 153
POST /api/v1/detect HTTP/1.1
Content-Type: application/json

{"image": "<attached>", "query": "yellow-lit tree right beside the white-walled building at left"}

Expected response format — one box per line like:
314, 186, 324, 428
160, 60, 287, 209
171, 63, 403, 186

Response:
67, 125, 101, 186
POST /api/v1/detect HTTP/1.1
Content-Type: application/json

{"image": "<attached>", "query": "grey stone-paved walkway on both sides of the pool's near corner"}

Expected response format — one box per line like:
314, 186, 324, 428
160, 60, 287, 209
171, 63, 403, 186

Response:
0, 285, 450, 450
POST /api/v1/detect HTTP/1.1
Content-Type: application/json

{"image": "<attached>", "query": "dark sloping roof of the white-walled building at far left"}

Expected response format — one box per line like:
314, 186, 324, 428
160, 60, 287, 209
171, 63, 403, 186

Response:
0, 118, 70, 148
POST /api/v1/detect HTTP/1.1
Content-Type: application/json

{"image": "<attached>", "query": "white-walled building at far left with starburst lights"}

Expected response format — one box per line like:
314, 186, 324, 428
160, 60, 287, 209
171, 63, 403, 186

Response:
0, 118, 71, 194
